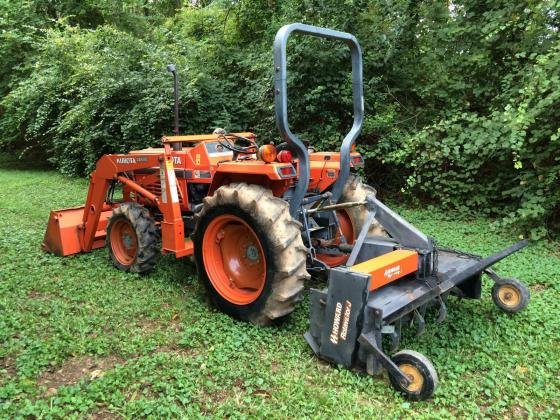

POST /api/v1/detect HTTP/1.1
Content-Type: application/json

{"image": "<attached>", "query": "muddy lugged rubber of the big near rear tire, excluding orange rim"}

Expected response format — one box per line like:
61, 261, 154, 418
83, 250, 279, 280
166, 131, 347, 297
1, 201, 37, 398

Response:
193, 183, 310, 325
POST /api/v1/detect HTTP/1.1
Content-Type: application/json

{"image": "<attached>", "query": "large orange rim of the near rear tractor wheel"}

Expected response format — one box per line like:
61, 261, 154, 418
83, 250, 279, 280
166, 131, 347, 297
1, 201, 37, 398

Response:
202, 214, 266, 305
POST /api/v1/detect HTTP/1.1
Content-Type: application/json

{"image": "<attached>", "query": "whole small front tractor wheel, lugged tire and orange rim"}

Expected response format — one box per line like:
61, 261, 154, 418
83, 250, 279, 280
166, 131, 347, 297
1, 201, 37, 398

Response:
105, 203, 159, 274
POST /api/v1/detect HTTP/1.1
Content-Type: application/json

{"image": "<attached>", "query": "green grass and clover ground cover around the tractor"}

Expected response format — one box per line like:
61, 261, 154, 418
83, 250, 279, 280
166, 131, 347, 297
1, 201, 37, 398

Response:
0, 160, 560, 418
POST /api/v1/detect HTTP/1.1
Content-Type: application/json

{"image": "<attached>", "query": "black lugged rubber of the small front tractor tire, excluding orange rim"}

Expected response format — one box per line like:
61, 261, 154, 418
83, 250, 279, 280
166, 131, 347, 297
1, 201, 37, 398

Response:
105, 203, 160, 274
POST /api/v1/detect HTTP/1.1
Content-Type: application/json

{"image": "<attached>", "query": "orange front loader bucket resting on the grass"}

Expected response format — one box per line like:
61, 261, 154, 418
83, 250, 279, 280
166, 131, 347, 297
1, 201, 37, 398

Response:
41, 207, 111, 257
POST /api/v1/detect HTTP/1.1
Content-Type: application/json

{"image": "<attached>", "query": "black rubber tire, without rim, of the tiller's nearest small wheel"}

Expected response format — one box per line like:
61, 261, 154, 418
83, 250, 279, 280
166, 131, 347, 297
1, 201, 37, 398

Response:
389, 350, 438, 401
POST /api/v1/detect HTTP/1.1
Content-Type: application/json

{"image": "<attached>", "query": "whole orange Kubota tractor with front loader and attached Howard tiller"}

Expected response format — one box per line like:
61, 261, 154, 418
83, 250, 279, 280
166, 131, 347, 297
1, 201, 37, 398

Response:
43, 24, 529, 399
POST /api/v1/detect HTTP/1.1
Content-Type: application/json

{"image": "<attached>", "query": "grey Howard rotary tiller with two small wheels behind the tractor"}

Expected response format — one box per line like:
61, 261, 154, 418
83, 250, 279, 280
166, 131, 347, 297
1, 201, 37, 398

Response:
305, 197, 529, 400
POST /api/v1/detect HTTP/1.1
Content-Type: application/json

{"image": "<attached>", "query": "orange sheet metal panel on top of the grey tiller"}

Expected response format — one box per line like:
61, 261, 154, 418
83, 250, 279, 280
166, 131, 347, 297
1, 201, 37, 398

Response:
350, 249, 418, 291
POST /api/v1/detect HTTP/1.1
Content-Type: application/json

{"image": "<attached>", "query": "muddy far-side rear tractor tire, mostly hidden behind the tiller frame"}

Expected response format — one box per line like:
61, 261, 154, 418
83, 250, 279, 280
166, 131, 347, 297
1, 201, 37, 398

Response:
339, 174, 387, 238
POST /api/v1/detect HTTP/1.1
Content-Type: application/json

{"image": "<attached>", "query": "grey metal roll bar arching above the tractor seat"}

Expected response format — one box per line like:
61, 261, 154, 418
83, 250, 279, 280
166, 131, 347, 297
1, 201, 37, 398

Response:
274, 23, 364, 217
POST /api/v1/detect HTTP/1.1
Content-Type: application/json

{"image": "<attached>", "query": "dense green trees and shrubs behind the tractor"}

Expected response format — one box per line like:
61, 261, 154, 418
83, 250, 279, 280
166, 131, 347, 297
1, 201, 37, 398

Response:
0, 0, 560, 237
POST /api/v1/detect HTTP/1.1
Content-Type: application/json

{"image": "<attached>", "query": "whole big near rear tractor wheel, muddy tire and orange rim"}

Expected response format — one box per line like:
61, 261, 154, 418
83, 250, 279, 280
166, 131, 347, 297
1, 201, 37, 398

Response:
193, 183, 309, 325
